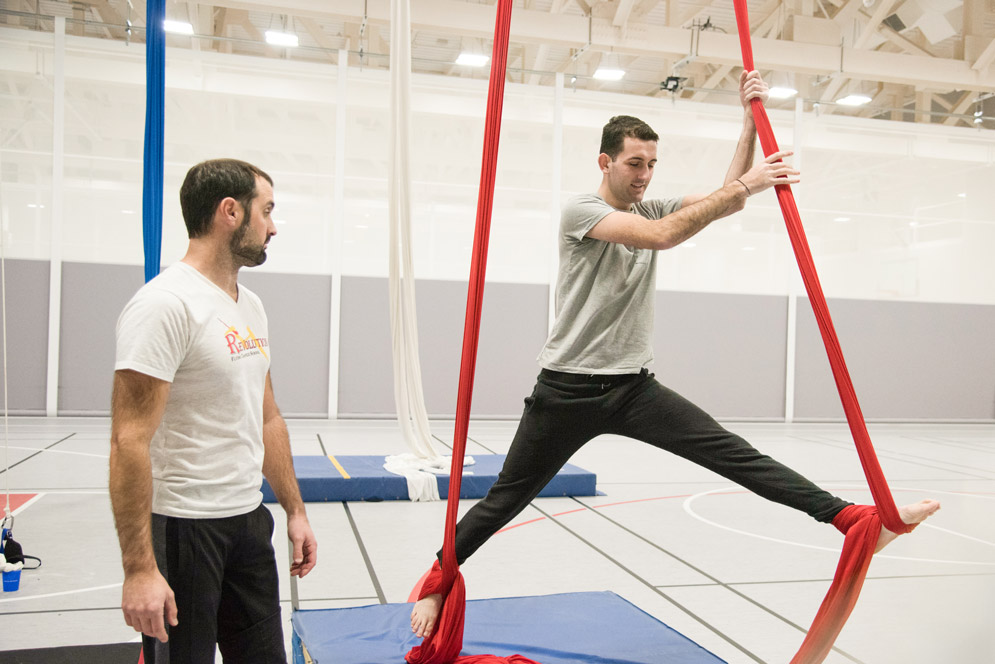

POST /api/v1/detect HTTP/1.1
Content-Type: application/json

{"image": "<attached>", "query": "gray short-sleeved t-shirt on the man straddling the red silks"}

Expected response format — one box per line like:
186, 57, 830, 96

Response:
539, 194, 683, 374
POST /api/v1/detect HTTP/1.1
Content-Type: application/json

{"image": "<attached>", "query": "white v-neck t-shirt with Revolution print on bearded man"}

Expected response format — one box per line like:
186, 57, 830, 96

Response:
114, 263, 270, 519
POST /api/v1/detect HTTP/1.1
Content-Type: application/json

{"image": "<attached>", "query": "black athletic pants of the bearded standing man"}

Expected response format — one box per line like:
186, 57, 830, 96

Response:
142, 505, 287, 664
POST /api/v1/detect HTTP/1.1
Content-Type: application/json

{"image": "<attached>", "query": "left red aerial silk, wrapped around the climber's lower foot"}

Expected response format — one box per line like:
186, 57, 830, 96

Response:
404, 0, 538, 664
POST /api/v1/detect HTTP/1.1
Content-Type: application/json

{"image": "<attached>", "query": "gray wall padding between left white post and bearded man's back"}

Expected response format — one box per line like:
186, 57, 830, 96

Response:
57, 263, 145, 415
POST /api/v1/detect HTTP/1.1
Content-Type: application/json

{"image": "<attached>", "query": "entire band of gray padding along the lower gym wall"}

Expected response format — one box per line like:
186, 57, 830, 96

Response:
15, 260, 995, 421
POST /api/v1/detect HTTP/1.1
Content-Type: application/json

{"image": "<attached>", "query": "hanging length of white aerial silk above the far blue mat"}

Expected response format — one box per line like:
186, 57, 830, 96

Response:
388, 0, 440, 460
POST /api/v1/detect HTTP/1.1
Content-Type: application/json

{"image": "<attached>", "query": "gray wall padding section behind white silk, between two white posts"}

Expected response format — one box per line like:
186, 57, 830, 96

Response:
339, 277, 548, 417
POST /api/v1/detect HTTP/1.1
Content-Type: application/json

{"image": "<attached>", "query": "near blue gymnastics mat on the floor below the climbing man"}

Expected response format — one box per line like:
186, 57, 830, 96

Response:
291, 592, 725, 664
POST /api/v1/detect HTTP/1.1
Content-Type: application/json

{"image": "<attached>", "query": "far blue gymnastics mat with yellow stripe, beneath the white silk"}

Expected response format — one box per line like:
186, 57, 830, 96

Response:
263, 454, 597, 503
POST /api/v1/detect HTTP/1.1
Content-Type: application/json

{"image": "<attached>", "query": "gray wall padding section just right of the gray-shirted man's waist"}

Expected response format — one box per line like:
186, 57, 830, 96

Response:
653, 291, 787, 419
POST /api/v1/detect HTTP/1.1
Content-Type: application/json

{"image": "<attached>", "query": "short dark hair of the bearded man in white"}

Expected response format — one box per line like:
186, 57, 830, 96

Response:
180, 159, 273, 238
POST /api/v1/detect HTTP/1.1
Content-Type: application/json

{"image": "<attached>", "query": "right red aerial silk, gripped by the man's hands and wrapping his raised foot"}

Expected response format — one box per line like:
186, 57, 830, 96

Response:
733, 0, 913, 664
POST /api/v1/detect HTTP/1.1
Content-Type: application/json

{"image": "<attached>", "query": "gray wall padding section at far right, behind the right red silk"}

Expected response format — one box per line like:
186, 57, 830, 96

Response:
795, 298, 995, 420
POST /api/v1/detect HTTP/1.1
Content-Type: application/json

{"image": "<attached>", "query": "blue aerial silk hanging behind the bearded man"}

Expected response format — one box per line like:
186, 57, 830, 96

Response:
142, 0, 166, 281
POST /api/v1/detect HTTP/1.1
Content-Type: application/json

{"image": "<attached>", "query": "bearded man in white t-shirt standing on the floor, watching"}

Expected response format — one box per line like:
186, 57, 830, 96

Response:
110, 159, 317, 664
